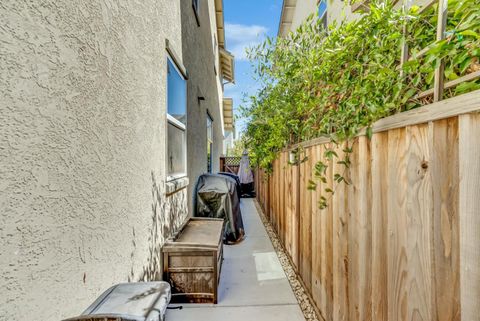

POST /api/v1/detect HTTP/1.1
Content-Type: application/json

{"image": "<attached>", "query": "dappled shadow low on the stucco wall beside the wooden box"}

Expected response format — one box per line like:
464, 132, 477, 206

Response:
128, 171, 188, 282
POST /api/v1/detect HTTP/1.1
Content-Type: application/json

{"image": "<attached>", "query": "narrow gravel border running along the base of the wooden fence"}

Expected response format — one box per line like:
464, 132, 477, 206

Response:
253, 199, 324, 321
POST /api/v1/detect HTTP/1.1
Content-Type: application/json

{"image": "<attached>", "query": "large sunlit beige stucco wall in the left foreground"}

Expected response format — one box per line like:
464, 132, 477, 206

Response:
0, 0, 187, 321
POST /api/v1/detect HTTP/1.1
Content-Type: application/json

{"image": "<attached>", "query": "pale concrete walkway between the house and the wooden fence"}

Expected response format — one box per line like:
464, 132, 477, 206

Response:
166, 199, 305, 321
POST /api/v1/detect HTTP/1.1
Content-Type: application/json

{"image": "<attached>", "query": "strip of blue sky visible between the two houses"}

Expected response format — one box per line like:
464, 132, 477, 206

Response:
223, 0, 282, 132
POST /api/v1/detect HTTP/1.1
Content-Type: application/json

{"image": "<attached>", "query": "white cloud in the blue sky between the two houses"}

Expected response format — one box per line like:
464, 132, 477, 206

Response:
225, 23, 268, 60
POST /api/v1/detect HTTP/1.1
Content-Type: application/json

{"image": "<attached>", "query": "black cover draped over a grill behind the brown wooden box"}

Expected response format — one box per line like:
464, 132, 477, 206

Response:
195, 174, 245, 244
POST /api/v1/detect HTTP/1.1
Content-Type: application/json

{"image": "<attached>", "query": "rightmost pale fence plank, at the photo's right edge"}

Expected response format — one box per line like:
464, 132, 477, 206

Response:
459, 114, 480, 321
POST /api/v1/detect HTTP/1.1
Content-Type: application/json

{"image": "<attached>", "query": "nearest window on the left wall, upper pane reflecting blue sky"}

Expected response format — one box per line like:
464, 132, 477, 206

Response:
167, 57, 187, 180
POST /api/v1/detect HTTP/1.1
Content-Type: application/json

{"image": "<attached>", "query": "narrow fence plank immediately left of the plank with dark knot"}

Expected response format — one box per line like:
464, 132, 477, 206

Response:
386, 129, 408, 321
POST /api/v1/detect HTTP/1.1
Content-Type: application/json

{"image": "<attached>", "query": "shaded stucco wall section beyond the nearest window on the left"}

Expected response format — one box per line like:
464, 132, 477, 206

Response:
181, 0, 223, 209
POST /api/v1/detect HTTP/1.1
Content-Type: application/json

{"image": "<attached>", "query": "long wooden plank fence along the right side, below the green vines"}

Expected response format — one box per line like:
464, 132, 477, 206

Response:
256, 91, 480, 321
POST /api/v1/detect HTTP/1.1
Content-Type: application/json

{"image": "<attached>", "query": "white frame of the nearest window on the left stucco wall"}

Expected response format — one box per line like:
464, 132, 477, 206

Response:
165, 52, 188, 182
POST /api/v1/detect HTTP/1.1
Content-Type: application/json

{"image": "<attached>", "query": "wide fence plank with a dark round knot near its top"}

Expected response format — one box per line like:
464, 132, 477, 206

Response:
404, 124, 436, 320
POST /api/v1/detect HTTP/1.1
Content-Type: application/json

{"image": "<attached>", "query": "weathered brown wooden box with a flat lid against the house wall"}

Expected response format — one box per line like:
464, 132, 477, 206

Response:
162, 217, 223, 304
